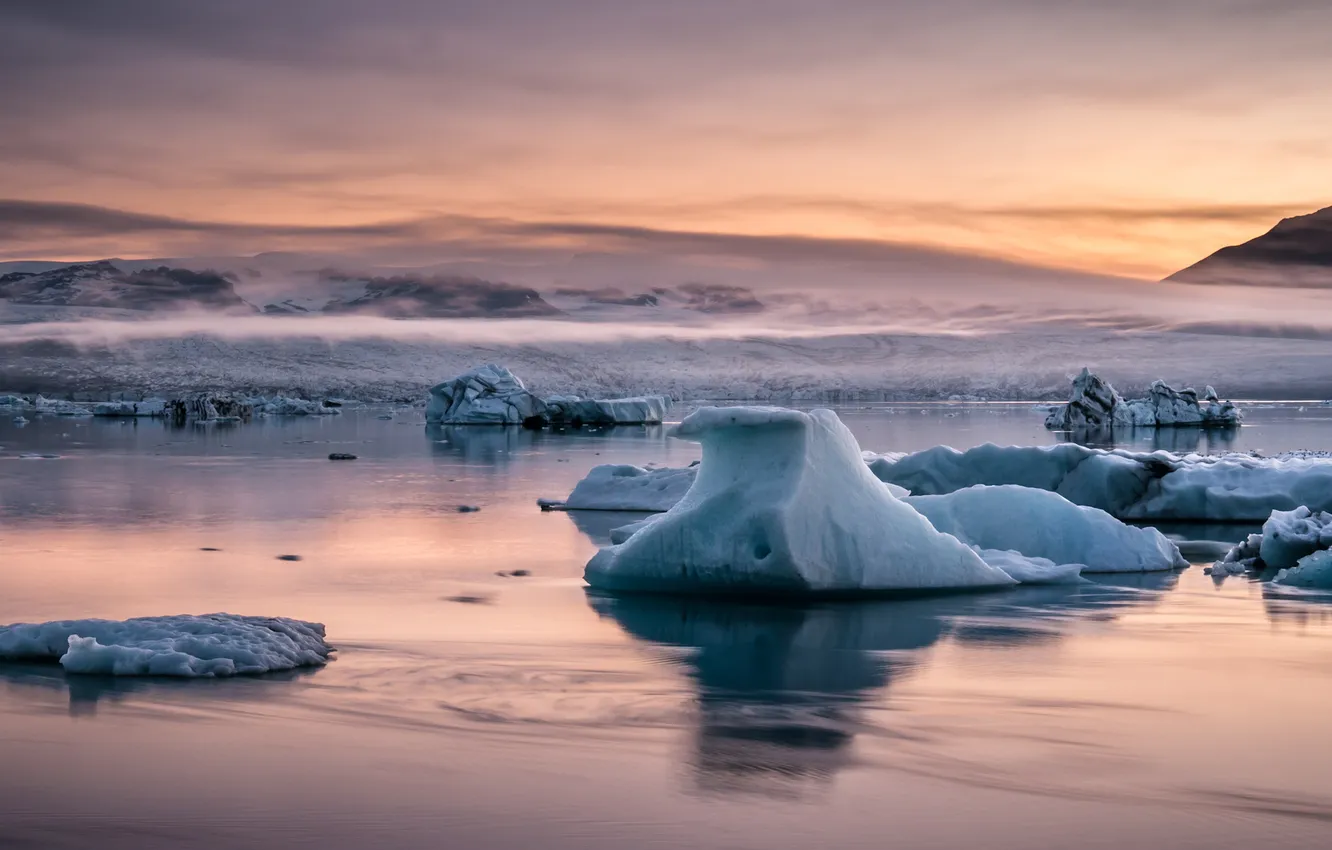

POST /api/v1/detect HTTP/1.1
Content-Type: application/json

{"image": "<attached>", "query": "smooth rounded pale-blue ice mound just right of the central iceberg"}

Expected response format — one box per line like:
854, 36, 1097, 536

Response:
906, 485, 1188, 573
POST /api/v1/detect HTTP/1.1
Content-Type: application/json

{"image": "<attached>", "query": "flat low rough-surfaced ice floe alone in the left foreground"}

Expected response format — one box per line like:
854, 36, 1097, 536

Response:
0, 614, 333, 677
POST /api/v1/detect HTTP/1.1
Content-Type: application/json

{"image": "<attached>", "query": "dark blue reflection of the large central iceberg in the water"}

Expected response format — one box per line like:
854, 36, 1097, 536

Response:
587, 573, 1177, 797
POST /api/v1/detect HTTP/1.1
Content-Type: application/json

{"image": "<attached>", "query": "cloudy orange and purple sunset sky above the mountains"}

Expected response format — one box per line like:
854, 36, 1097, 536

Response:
0, 0, 1332, 278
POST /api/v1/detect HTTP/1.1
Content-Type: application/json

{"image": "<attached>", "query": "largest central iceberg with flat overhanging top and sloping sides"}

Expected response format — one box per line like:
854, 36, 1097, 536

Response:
585, 408, 1016, 594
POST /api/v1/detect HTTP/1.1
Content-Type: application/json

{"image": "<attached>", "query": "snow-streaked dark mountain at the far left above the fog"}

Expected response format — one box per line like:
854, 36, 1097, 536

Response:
0, 260, 254, 312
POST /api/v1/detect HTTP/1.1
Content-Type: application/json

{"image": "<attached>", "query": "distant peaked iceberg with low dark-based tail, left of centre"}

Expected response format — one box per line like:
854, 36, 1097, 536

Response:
425, 364, 670, 426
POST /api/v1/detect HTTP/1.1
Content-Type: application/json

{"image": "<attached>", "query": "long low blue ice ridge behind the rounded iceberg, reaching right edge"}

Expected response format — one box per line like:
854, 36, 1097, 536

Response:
870, 444, 1332, 522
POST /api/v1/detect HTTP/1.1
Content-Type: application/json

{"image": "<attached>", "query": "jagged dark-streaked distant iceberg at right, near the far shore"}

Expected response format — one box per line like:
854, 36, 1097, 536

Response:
1046, 368, 1243, 430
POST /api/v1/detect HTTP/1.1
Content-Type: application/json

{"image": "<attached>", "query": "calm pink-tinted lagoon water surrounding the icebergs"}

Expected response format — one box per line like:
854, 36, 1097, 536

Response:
0, 405, 1332, 850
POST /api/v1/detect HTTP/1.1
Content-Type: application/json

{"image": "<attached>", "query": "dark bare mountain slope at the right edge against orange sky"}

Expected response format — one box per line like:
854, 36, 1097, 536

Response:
1166, 207, 1332, 289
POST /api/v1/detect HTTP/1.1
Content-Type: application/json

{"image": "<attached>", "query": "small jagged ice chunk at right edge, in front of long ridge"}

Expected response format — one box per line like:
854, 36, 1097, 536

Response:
1208, 505, 1332, 590
